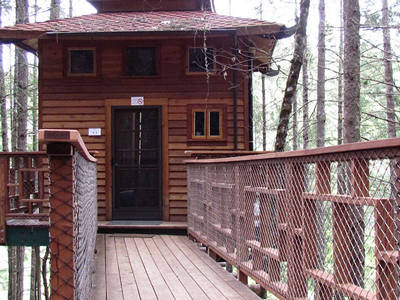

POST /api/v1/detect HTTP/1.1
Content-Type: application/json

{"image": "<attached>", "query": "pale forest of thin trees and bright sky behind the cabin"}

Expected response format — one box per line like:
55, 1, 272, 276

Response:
0, 0, 400, 299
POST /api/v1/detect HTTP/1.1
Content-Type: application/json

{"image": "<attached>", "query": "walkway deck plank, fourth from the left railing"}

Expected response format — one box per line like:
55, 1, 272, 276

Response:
125, 238, 157, 300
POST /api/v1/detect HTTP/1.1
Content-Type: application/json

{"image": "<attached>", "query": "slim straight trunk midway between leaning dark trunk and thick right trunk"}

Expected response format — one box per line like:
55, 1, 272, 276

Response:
317, 0, 326, 147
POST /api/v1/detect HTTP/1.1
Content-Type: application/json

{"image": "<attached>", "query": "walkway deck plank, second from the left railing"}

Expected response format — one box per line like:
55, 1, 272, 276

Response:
106, 236, 123, 299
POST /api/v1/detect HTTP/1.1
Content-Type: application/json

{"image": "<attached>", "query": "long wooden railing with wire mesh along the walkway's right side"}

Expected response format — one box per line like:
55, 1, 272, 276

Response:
187, 139, 400, 300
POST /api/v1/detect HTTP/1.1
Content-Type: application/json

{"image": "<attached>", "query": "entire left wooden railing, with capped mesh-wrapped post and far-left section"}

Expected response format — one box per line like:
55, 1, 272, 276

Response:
0, 130, 97, 300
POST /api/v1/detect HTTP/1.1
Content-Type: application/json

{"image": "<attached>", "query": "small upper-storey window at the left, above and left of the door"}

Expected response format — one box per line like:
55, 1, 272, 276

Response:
68, 48, 96, 76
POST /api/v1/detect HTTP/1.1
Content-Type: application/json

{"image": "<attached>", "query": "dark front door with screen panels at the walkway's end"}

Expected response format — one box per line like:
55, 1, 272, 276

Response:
112, 106, 162, 220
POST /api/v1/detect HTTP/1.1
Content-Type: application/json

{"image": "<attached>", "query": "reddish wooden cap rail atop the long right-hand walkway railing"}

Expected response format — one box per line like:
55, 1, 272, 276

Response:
185, 138, 400, 164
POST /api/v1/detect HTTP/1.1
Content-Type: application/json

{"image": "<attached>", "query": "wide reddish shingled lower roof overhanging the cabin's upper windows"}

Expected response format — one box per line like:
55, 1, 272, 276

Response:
0, 11, 291, 74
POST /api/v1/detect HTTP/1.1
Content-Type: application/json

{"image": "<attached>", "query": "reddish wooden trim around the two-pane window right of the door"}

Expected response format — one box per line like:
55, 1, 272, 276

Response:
187, 104, 227, 142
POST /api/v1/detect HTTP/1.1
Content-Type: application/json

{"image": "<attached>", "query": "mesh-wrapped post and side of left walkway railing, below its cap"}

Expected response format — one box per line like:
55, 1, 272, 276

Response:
50, 145, 97, 300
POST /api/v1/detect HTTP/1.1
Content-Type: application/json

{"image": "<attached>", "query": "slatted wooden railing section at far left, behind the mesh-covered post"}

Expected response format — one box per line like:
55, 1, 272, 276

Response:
0, 152, 49, 245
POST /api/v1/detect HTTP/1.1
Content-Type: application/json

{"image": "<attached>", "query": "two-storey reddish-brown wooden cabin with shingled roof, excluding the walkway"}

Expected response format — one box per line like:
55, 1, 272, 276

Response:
0, 0, 287, 221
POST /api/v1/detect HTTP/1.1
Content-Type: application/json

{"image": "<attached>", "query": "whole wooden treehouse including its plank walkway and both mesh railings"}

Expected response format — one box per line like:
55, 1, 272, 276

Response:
0, 0, 400, 300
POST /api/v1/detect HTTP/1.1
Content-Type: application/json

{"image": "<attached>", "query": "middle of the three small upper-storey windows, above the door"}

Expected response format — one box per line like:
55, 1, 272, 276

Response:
126, 47, 157, 76
